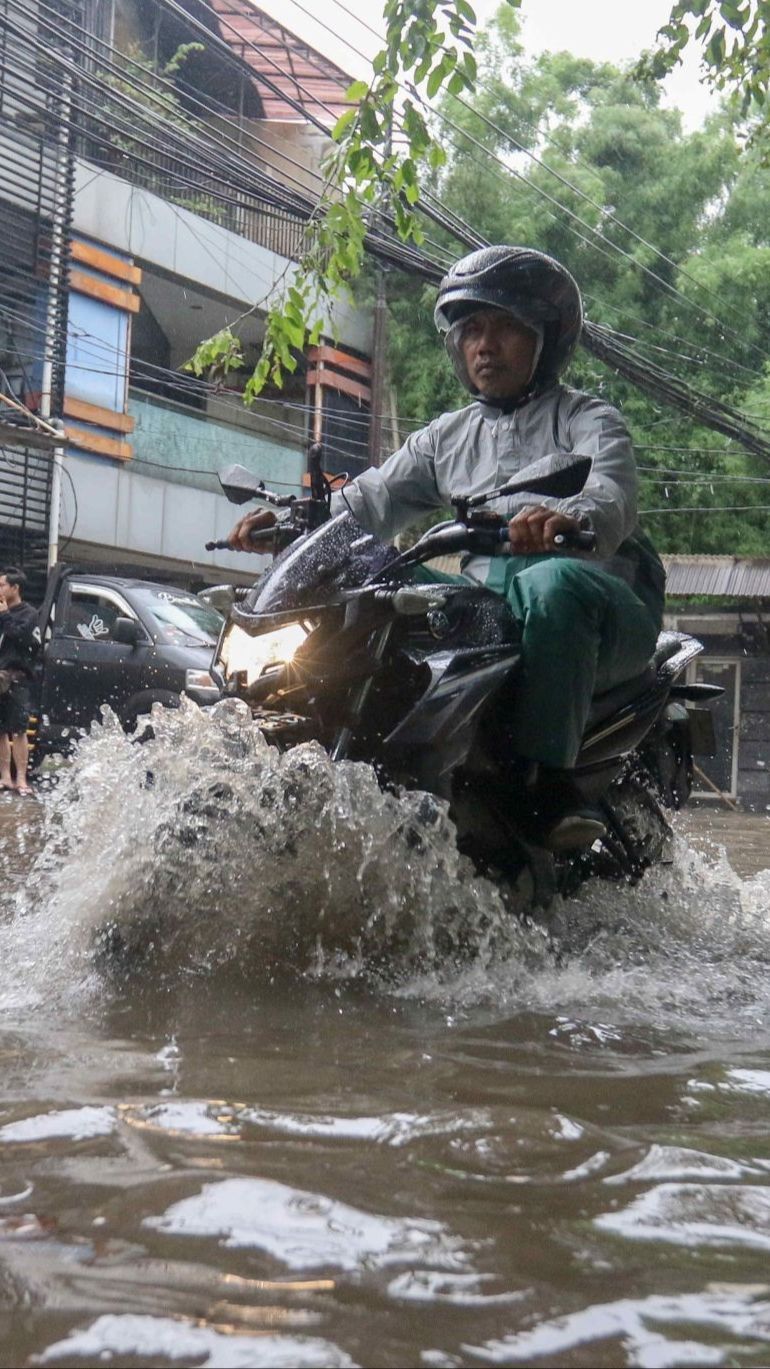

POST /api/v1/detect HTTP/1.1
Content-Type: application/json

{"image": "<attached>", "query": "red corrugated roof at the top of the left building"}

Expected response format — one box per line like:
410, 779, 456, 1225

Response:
211, 0, 352, 129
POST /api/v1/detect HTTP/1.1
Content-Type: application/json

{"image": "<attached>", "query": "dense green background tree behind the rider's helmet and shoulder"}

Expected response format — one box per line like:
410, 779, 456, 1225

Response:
390, 10, 770, 554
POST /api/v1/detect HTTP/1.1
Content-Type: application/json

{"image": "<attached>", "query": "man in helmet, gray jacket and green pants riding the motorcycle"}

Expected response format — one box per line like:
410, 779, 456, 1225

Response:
229, 246, 665, 850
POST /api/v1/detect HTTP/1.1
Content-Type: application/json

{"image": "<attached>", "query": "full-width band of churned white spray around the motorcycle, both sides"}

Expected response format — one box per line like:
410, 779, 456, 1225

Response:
0, 701, 770, 1029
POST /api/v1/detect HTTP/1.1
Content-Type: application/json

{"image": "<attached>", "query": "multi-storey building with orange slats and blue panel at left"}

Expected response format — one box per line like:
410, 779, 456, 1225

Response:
0, 0, 371, 599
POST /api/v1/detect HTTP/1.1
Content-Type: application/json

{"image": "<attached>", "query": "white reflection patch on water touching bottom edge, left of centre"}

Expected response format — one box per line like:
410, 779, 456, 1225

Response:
33, 1313, 356, 1369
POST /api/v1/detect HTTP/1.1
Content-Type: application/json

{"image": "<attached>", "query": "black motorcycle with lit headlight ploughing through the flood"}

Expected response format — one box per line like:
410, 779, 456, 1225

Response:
203, 445, 721, 912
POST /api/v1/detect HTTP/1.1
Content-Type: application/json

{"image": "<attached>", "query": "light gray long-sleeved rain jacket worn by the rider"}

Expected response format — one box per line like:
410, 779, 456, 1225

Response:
332, 385, 665, 619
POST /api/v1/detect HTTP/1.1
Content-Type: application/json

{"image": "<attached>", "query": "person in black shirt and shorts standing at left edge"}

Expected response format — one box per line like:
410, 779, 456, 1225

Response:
0, 565, 40, 795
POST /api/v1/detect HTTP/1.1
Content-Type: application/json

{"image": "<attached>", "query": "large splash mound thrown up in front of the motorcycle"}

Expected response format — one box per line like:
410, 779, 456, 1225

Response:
0, 704, 545, 995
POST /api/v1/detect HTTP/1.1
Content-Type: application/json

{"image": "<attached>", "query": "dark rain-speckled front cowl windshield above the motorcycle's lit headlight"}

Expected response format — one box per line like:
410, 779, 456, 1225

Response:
238, 513, 397, 617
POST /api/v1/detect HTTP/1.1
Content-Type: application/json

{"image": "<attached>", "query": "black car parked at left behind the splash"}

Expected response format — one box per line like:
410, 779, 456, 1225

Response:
30, 567, 222, 761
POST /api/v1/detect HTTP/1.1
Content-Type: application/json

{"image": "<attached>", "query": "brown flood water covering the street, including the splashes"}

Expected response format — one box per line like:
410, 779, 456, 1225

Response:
0, 706, 770, 1369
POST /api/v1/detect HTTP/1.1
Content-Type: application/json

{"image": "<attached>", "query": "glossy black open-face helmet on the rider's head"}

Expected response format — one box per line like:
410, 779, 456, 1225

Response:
433, 246, 582, 393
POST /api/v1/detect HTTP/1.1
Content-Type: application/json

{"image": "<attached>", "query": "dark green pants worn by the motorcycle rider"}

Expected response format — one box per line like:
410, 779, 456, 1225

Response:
415, 554, 660, 769
